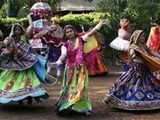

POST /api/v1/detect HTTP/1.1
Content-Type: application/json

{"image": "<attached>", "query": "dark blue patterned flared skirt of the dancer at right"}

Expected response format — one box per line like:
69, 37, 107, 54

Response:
106, 63, 160, 110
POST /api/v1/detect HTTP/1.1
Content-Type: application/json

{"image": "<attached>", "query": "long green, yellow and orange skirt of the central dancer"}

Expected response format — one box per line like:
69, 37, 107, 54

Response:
57, 66, 92, 113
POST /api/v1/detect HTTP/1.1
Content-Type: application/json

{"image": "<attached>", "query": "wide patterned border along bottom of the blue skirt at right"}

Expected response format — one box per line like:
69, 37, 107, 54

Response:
105, 95, 160, 110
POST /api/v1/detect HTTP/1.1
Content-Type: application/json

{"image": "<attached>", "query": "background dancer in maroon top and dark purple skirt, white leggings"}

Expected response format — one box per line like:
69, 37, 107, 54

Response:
36, 21, 64, 78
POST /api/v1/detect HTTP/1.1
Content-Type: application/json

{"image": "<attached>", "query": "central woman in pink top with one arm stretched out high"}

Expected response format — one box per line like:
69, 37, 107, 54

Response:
56, 21, 109, 115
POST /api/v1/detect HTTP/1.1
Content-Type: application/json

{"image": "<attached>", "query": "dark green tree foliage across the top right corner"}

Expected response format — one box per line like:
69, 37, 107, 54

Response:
94, 0, 160, 30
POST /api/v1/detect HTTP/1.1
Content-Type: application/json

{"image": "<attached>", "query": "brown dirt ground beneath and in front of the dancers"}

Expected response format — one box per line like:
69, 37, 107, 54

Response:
0, 75, 160, 120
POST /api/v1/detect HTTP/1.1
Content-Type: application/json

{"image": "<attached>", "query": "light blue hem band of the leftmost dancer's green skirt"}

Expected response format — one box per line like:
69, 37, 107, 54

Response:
0, 87, 49, 104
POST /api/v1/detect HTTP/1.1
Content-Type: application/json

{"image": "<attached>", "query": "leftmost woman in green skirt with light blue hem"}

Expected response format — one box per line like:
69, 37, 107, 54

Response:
0, 24, 48, 104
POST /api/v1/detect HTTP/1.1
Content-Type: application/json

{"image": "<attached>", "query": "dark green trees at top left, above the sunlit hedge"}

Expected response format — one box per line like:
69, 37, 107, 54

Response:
0, 0, 59, 18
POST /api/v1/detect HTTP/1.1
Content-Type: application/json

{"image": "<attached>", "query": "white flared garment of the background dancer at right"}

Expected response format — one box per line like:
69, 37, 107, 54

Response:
109, 37, 129, 51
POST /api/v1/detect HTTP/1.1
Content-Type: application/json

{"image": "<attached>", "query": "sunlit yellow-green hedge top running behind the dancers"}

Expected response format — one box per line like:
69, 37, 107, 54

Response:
0, 12, 109, 27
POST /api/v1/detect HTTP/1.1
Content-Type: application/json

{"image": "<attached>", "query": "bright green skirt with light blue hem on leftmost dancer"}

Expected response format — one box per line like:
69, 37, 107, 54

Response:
0, 67, 48, 104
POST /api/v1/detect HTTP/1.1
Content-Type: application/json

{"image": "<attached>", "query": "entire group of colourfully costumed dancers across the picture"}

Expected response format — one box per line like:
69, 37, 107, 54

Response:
0, 2, 160, 115
